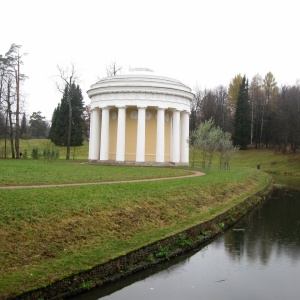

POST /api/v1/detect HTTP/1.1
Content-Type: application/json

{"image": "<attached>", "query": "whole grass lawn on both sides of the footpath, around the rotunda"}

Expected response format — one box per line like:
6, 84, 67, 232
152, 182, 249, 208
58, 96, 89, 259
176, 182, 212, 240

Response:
0, 140, 299, 299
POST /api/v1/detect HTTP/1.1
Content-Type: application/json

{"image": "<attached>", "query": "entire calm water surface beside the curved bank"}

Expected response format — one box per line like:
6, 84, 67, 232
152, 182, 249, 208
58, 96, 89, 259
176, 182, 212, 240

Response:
73, 189, 300, 300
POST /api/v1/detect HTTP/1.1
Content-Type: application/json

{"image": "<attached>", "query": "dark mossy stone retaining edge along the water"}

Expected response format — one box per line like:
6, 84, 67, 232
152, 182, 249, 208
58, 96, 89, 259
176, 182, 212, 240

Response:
7, 181, 273, 300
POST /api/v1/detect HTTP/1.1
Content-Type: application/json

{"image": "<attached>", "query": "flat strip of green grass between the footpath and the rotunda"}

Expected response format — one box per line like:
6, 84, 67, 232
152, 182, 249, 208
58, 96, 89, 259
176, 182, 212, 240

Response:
0, 159, 190, 186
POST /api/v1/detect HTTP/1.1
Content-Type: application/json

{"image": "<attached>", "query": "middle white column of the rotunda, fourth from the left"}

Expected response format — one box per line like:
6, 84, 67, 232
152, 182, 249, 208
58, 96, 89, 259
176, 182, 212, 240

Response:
135, 107, 146, 162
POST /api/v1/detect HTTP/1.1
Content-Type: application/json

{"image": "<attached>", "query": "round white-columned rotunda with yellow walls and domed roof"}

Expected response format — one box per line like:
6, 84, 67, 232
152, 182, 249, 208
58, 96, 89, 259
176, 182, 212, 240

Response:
87, 68, 193, 165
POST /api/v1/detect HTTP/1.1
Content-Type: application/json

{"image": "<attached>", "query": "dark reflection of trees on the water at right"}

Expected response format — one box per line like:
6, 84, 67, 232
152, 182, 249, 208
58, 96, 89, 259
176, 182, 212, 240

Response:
220, 189, 300, 264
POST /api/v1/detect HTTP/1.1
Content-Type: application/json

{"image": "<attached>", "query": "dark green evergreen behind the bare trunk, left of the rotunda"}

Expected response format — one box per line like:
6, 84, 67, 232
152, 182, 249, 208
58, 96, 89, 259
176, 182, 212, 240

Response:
49, 83, 84, 146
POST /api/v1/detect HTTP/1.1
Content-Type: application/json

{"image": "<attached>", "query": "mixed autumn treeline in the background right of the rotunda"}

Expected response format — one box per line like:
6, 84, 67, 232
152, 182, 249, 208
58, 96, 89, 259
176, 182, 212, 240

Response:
190, 72, 300, 153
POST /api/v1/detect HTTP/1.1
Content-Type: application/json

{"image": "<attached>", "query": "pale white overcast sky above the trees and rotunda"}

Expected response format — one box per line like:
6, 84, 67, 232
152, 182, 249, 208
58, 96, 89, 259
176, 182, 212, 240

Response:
0, 0, 300, 119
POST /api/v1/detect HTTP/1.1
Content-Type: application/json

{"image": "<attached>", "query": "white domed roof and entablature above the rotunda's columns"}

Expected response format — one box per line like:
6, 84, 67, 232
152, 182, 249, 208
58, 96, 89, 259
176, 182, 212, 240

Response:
87, 72, 194, 111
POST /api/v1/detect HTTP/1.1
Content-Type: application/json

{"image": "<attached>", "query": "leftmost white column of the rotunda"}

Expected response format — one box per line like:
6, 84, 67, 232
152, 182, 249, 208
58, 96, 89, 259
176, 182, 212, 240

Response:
89, 108, 100, 160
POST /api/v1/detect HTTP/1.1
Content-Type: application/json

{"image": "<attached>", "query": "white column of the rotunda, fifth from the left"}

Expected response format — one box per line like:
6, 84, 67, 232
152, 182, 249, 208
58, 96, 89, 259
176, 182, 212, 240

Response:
156, 107, 165, 162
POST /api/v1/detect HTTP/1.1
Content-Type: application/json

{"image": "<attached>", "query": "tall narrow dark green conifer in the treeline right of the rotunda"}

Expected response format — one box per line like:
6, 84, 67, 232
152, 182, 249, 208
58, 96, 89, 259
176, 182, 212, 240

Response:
233, 76, 251, 150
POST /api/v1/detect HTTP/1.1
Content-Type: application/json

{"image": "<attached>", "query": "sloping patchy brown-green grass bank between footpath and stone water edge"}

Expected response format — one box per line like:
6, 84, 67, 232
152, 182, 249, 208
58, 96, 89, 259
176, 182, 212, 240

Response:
0, 166, 270, 299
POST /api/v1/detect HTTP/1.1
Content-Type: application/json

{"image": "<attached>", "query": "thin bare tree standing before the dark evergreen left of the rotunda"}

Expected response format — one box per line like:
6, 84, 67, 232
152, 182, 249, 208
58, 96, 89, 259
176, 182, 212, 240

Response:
56, 64, 78, 159
